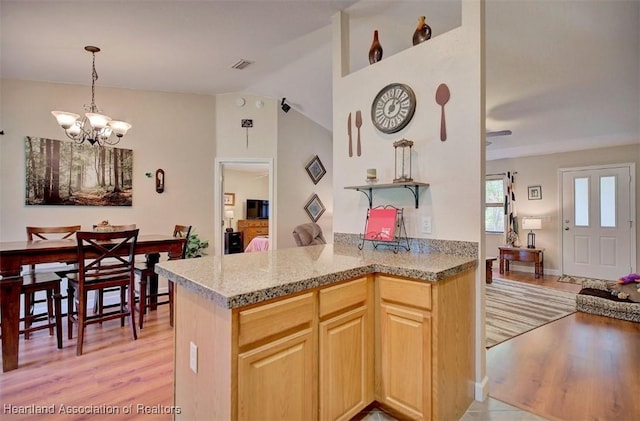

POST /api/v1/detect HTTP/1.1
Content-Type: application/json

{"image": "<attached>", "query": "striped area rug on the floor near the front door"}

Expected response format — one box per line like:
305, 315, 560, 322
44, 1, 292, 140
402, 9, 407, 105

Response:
485, 278, 576, 348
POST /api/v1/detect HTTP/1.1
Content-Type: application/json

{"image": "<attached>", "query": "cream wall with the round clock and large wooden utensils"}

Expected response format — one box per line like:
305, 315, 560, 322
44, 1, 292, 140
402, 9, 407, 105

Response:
333, 0, 487, 398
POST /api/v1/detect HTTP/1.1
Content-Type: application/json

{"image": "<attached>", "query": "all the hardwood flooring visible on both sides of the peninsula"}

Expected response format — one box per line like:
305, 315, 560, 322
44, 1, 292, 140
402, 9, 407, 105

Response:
0, 271, 640, 421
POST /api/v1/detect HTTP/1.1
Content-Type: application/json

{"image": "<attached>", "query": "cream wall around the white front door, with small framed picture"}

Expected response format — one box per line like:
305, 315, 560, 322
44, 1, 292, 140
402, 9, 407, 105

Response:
486, 143, 640, 275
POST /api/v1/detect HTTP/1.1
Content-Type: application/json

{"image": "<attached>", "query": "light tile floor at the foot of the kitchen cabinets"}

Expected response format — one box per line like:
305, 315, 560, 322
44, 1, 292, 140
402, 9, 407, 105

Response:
355, 398, 546, 421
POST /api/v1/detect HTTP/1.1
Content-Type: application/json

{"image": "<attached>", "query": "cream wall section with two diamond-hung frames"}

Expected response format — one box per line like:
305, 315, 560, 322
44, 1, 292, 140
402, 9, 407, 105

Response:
277, 108, 333, 248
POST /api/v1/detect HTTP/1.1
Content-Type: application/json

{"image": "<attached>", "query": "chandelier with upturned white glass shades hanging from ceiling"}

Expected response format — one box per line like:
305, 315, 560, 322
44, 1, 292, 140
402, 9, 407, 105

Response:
51, 46, 131, 146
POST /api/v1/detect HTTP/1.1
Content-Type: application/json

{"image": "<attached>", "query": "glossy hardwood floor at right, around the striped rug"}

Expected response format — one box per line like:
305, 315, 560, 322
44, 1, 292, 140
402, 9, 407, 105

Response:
487, 272, 640, 421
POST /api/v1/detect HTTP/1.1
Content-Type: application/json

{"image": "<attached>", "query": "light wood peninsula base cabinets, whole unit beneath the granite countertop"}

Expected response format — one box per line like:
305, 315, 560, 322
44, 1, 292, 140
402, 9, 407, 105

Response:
175, 270, 475, 420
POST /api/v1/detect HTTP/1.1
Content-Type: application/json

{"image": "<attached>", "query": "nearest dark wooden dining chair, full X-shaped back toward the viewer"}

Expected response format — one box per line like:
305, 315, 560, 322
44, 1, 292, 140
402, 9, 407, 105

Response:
67, 229, 138, 355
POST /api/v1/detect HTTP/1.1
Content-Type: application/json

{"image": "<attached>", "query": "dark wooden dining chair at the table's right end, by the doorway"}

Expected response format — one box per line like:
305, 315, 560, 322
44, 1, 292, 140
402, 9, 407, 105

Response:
135, 225, 191, 329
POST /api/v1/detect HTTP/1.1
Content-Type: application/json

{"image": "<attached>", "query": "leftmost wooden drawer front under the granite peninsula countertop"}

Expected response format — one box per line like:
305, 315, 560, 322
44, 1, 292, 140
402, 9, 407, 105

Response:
238, 292, 314, 346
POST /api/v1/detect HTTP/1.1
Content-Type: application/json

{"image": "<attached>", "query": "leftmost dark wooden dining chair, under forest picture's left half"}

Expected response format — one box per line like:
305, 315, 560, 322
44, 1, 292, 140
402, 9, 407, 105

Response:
22, 225, 81, 339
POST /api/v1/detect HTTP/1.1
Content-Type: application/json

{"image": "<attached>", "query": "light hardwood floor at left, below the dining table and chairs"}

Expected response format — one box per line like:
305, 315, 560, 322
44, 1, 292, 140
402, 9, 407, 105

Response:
0, 306, 173, 421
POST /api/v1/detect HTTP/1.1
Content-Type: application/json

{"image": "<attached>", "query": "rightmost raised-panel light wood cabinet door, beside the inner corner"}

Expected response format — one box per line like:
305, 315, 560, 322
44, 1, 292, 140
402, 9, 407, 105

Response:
378, 302, 431, 419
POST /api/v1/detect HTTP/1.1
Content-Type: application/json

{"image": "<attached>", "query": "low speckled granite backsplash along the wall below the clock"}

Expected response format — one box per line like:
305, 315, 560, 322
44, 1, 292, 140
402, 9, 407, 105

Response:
333, 232, 478, 258
